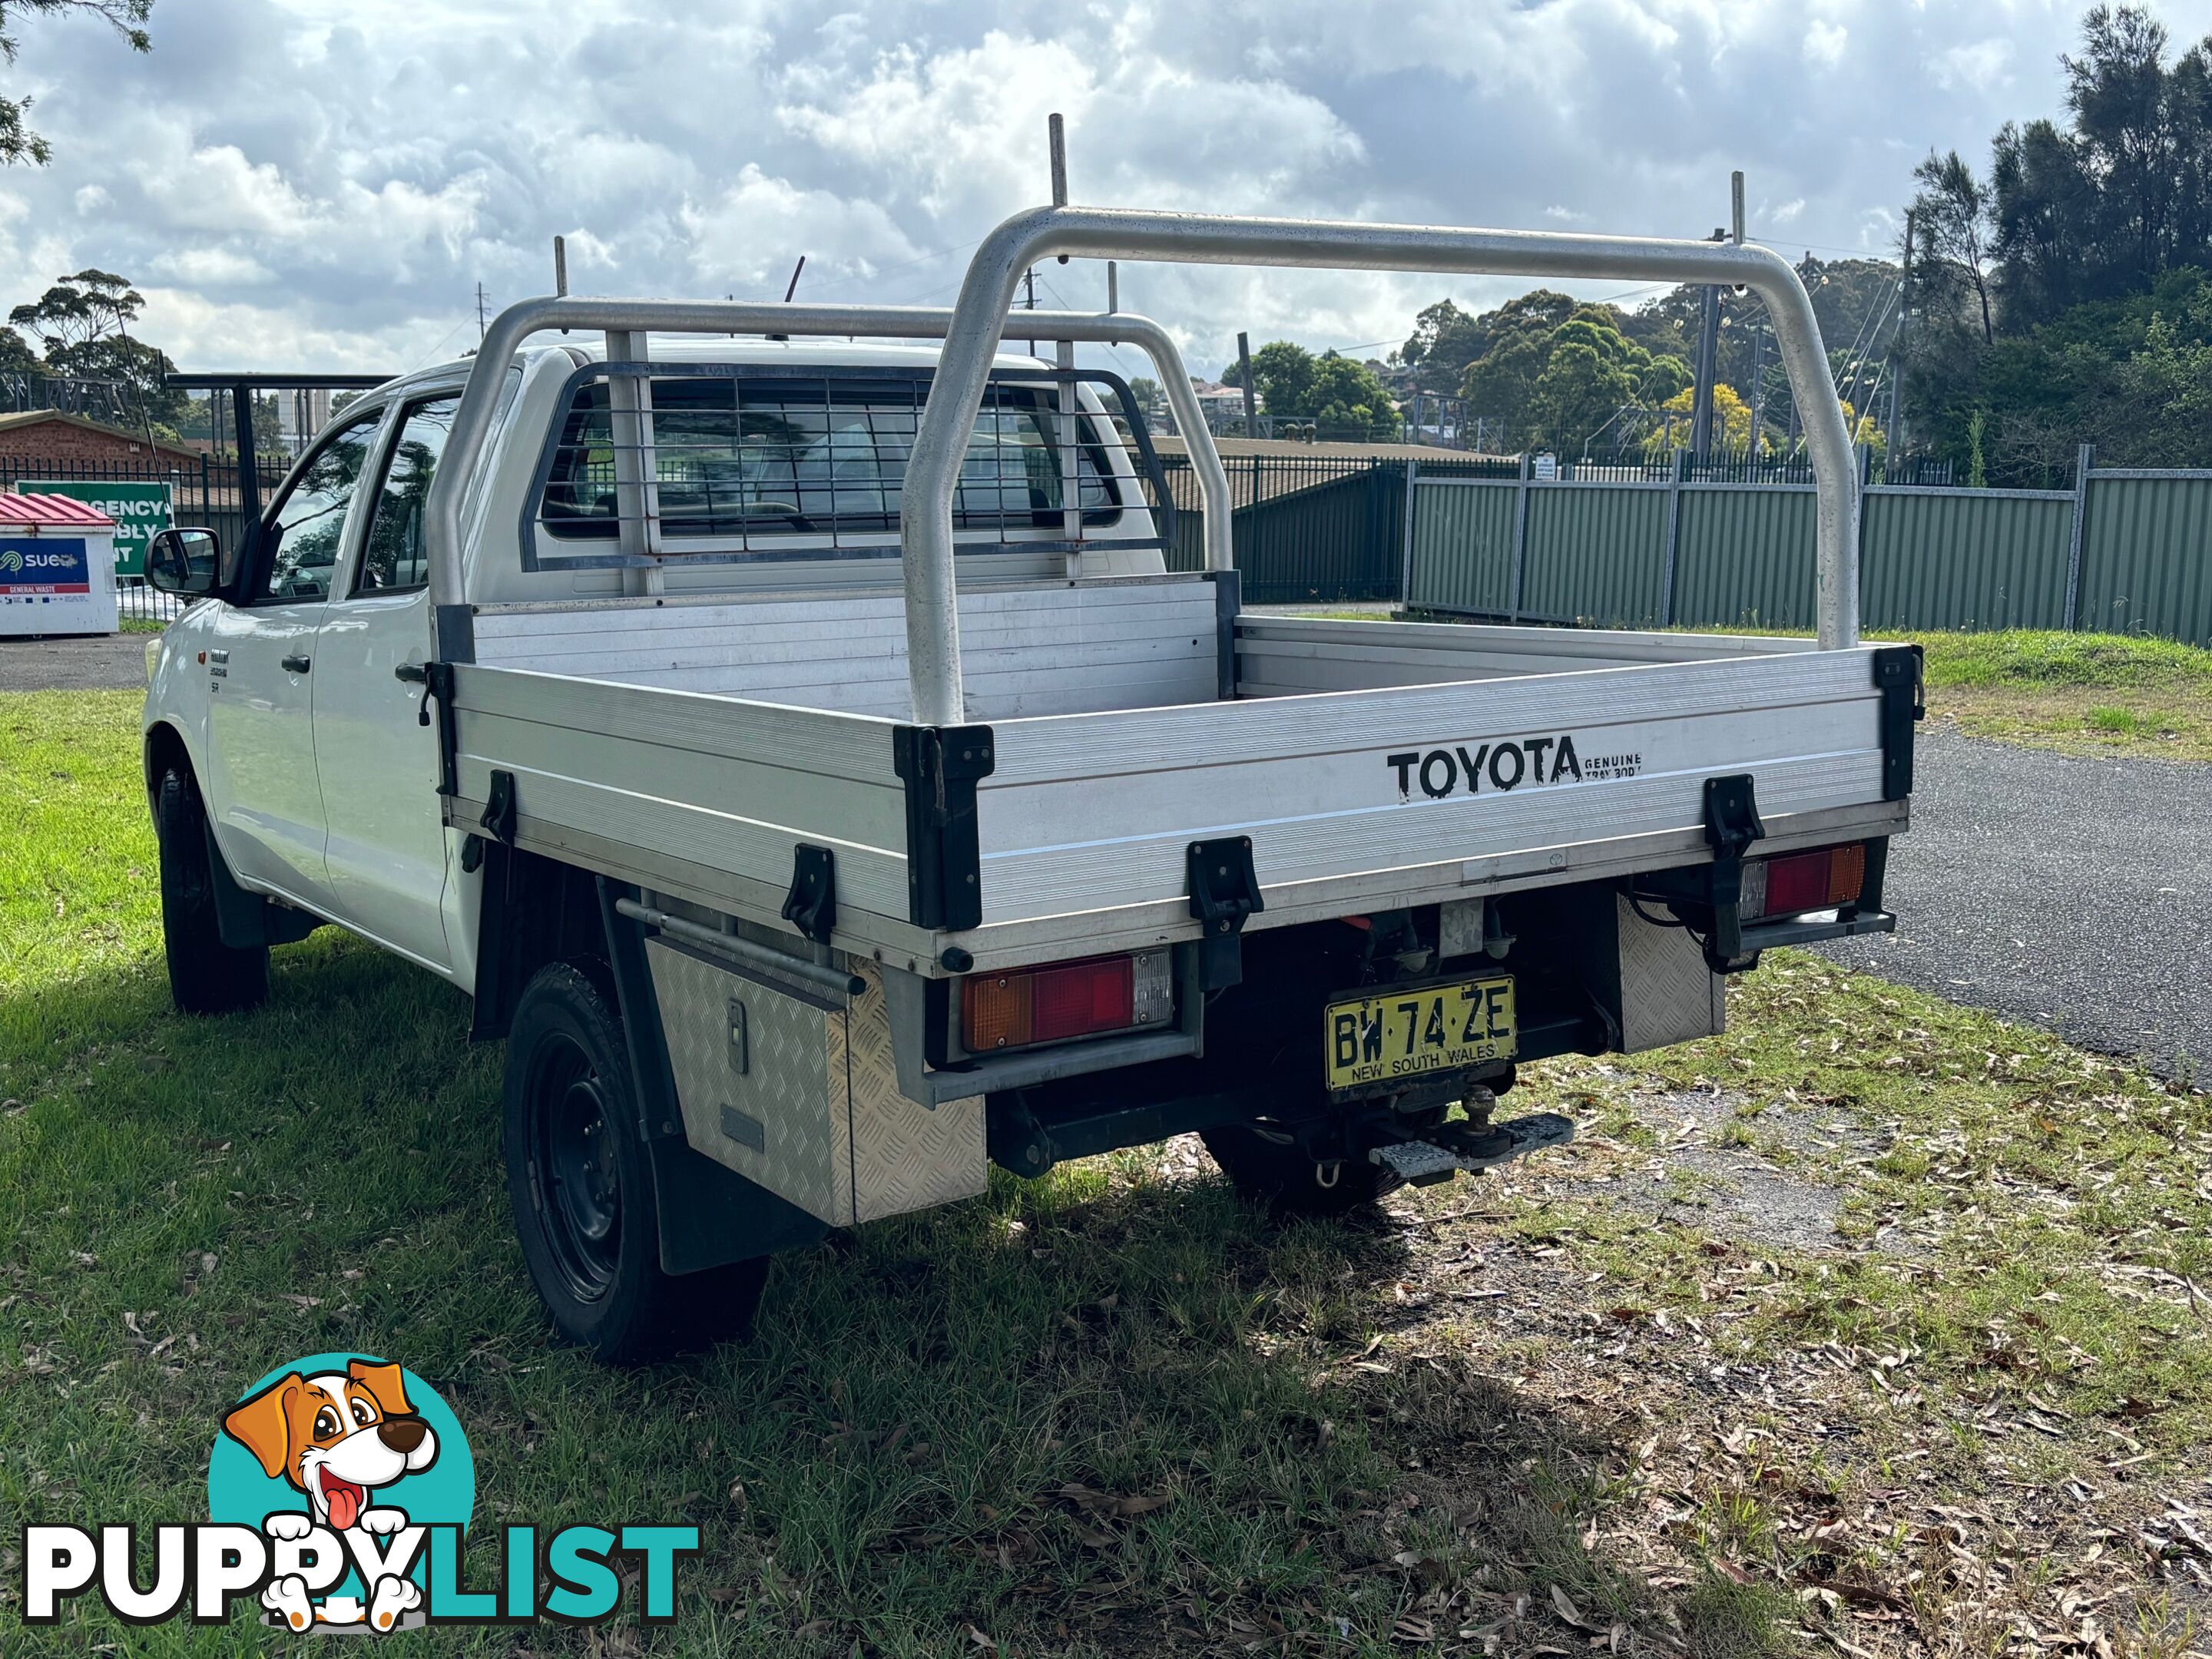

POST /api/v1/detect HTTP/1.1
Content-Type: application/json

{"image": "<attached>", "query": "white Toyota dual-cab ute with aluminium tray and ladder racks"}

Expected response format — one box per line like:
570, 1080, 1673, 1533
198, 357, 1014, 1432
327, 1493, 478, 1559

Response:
144, 208, 1920, 1360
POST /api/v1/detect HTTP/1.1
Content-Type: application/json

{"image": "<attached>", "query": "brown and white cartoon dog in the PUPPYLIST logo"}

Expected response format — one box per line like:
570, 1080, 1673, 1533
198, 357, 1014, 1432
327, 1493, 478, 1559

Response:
224, 1360, 438, 1631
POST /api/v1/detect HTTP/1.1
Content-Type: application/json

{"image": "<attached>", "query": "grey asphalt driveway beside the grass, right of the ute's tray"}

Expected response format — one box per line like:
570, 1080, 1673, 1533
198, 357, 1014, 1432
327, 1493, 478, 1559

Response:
1823, 726, 2212, 1078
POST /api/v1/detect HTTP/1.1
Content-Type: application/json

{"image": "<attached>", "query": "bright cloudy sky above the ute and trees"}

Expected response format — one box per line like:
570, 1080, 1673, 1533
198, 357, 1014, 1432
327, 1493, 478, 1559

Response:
0, 0, 2212, 372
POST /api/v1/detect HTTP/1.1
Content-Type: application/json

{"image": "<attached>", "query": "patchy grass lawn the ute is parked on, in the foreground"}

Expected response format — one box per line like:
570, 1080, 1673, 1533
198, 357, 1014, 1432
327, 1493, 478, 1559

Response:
0, 692, 2212, 1659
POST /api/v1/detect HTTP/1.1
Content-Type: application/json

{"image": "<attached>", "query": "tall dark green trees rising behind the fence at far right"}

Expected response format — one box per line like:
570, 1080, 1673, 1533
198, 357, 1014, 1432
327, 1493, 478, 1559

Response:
1902, 5, 2212, 487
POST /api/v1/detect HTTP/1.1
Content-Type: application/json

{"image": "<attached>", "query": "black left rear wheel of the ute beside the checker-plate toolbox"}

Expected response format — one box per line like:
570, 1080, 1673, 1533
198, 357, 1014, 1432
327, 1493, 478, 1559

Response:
505, 962, 767, 1365
